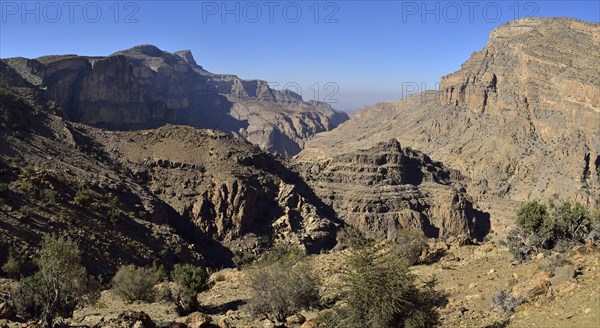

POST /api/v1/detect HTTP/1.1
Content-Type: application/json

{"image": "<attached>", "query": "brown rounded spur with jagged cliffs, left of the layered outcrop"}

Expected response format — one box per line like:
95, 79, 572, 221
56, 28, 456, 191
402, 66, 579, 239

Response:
91, 126, 337, 252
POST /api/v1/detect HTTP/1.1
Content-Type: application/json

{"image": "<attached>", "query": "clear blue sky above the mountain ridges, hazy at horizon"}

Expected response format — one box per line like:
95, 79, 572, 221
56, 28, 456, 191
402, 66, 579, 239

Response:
0, 0, 600, 111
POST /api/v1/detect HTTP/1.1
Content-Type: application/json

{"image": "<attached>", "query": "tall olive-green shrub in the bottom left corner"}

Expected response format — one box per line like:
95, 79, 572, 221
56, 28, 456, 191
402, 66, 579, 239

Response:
11, 236, 99, 327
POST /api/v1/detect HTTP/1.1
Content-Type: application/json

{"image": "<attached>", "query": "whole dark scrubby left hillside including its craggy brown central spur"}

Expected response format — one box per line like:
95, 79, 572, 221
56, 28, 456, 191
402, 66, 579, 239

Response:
0, 63, 335, 274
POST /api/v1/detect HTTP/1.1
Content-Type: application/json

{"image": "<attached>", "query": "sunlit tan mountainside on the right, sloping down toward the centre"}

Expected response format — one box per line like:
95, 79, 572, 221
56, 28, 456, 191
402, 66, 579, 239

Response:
299, 18, 600, 233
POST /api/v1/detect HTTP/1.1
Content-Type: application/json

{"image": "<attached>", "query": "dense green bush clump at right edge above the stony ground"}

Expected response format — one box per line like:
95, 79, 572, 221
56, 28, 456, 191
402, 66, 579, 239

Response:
507, 198, 600, 260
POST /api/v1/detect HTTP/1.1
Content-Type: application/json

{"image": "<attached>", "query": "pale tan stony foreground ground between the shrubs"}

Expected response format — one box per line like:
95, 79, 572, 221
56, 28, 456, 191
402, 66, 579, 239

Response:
32, 242, 600, 328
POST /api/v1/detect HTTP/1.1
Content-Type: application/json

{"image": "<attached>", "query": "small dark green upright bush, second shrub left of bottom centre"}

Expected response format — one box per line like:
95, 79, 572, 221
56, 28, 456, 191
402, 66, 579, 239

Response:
171, 264, 209, 313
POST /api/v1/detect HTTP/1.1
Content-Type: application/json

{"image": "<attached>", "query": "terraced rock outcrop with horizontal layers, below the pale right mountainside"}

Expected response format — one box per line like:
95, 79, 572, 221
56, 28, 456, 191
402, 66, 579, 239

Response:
297, 139, 489, 239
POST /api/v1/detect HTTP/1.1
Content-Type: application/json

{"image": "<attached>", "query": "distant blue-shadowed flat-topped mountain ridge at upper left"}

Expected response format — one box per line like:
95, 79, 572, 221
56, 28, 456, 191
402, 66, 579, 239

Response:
4, 45, 348, 156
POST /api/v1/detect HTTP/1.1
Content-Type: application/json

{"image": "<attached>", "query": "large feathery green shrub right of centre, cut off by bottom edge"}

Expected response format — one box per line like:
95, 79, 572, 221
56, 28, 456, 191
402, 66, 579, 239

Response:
330, 243, 443, 328
